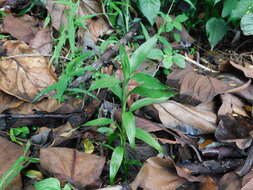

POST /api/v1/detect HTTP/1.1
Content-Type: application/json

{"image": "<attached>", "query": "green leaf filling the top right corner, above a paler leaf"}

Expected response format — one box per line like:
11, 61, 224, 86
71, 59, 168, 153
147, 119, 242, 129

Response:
231, 0, 253, 20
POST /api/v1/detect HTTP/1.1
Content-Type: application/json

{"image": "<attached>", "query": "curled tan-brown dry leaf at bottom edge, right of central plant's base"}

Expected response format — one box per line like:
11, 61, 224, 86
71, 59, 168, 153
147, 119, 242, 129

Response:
131, 157, 186, 190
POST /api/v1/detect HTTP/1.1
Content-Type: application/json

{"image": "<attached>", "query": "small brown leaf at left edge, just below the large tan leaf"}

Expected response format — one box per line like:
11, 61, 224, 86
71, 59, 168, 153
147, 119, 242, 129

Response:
0, 91, 24, 113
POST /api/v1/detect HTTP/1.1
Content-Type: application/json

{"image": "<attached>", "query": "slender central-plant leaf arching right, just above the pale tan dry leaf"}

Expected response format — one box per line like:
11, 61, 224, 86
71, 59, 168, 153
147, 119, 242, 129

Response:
130, 97, 170, 112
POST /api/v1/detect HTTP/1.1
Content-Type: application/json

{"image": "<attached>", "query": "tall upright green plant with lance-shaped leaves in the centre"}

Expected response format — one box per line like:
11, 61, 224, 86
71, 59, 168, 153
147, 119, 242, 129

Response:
84, 35, 174, 183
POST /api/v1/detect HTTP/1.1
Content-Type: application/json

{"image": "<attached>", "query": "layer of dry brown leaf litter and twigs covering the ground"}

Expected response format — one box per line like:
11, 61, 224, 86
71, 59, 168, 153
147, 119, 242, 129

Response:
0, 0, 253, 190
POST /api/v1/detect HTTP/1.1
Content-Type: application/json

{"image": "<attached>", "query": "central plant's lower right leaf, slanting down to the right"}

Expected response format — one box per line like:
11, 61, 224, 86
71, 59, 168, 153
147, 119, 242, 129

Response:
136, 128, 163, 152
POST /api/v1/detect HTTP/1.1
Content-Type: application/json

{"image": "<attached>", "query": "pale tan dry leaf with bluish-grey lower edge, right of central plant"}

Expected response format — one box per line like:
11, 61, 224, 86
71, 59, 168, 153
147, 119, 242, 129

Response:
154, 101, 217, 135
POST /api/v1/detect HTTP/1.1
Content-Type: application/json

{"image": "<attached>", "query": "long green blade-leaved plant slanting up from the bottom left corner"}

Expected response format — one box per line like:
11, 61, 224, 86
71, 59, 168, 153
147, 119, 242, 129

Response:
0, 141, 38, 190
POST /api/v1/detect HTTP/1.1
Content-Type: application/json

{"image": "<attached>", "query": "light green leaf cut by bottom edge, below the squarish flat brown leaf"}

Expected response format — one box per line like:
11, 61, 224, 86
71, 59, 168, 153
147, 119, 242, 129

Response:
34, 178, 61, 190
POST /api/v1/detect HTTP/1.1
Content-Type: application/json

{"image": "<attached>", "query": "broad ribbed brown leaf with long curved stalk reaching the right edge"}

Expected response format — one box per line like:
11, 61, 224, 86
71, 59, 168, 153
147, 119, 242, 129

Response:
167, 67, 251, 103
